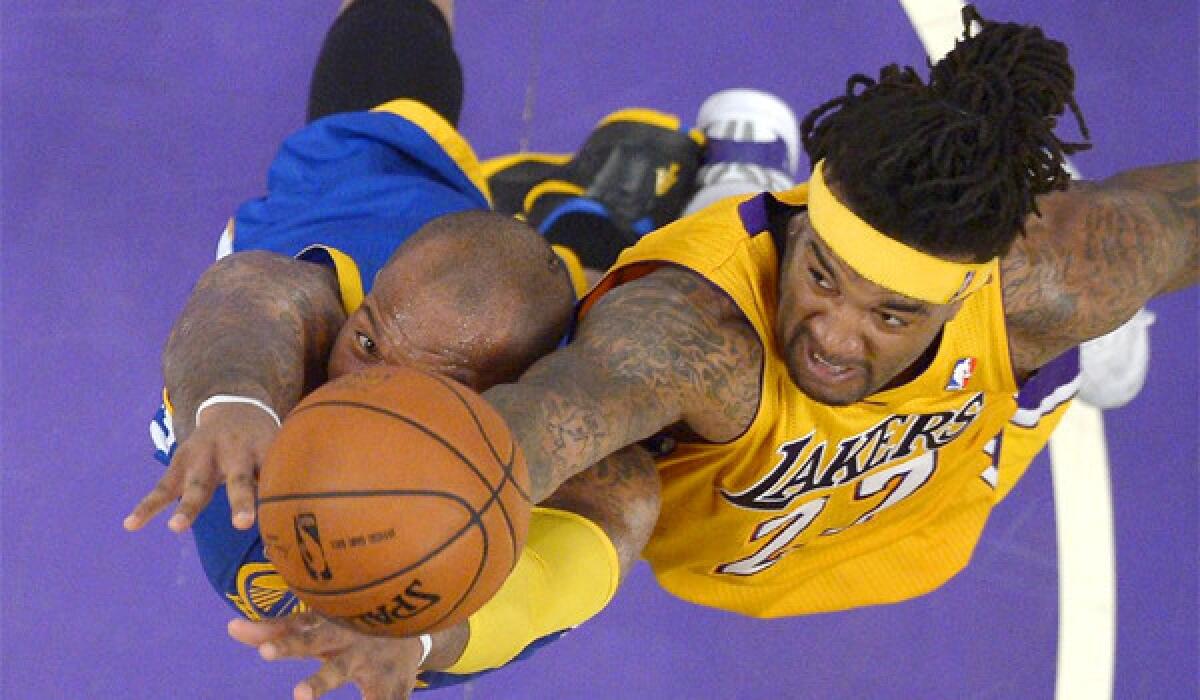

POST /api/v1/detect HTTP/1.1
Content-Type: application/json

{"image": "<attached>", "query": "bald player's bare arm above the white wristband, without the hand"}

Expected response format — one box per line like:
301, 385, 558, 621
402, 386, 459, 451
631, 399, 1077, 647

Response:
163, 252, 346, 439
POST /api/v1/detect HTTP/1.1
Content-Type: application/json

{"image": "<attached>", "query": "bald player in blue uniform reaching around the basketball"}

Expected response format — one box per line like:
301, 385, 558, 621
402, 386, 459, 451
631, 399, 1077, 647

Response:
119, 0, 729, 694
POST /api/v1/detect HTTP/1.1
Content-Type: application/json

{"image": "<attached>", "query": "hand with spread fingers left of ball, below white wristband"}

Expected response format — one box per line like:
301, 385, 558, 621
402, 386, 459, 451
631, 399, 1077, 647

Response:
125, 403, 280, 532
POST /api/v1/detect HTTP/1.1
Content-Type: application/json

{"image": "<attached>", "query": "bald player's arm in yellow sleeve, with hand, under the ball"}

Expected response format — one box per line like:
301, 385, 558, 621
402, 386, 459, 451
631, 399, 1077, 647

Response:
229, 447, 659, 698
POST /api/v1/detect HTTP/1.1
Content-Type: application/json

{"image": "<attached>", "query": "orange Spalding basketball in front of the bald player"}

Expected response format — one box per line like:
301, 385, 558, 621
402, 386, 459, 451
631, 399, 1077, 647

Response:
258, 367, 532, 636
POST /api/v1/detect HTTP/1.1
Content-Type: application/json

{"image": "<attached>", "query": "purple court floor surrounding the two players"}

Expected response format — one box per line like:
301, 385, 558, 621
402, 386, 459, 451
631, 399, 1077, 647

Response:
0, 0, 1200, 700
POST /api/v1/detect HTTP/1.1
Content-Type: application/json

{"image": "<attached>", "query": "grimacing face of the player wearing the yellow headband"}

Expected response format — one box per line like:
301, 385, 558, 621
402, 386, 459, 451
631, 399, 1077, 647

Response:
775, 214, 961, 406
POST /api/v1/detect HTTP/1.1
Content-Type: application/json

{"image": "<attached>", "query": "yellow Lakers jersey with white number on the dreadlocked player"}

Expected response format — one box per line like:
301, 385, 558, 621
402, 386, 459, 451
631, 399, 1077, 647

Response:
584, 185, 1016, 617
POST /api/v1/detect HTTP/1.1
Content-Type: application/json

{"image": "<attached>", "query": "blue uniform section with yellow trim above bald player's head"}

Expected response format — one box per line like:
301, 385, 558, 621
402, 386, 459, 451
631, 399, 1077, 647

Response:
218, 100, 491, 312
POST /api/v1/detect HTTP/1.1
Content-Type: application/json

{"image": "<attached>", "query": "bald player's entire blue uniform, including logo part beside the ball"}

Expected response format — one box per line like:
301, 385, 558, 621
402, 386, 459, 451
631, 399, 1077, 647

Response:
150, 100, 576, 688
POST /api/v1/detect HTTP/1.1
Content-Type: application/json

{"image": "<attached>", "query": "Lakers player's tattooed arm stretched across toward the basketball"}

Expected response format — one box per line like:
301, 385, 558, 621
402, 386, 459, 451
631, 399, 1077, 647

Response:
484, 268, 762, 501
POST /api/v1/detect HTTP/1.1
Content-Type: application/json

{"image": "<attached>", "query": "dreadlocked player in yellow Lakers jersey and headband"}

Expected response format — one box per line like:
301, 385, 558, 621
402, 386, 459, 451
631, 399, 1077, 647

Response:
218, 8, 1200, 696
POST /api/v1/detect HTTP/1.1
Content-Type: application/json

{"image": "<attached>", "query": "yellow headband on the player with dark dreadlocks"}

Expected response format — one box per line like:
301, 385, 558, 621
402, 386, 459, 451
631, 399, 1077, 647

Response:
809, 161, 991, 304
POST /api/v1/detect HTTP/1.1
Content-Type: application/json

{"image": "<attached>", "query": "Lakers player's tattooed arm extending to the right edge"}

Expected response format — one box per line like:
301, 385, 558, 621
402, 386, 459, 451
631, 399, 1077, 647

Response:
1001, 162, 1200, 376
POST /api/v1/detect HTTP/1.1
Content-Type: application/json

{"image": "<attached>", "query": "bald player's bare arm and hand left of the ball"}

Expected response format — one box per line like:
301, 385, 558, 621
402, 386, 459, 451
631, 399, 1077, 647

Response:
125, 251, 346, 532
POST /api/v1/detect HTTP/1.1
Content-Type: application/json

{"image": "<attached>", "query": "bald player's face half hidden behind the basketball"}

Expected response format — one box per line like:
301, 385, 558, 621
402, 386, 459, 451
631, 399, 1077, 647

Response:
328, 285, 482, 390
